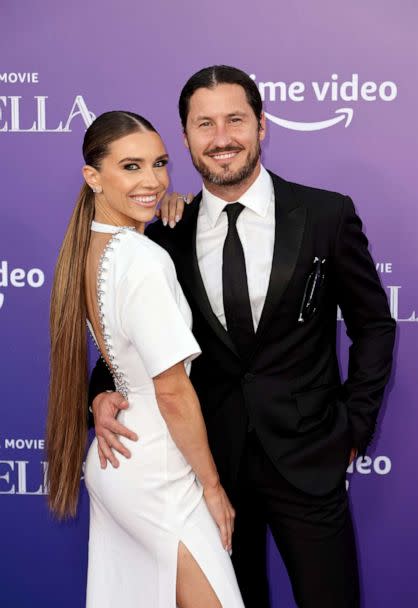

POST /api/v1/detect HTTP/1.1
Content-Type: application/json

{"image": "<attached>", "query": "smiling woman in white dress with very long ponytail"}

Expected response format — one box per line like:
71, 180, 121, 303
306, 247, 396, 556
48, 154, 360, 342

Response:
47, 112, 243, 608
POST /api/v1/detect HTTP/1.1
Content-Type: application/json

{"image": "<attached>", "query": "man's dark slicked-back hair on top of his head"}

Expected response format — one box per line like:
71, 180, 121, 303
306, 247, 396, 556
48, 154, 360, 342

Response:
179, 65, 263, 131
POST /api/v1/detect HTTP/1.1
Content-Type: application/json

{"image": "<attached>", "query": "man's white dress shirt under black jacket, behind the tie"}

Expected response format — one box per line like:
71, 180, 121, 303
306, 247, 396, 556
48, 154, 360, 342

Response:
196, 167, 275, 330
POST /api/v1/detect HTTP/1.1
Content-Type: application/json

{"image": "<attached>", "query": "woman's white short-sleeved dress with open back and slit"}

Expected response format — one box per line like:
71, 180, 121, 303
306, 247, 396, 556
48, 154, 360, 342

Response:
85, 222, 244, 608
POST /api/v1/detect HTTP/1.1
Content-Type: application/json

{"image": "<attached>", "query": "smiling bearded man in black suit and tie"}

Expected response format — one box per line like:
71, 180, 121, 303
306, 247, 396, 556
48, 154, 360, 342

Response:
88, 66, 395, 608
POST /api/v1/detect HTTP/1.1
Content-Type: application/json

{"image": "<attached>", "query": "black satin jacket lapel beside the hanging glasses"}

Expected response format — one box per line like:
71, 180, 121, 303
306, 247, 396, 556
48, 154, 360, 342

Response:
256, 173, 306, 345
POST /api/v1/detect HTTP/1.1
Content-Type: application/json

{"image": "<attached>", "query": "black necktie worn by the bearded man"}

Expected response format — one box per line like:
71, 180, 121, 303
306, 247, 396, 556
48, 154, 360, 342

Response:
222, 203, 255, 358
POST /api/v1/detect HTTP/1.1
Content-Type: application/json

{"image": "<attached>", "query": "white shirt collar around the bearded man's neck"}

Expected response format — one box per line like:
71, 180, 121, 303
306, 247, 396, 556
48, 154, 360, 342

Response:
202, 165, 274, 228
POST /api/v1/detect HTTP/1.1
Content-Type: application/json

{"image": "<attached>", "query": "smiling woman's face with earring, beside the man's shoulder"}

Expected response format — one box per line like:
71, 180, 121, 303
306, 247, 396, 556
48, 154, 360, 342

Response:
84, 131, 169, 227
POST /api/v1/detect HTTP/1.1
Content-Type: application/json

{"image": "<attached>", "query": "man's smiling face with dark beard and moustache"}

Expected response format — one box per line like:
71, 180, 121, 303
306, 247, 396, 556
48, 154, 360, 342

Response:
184, 84, 265, 186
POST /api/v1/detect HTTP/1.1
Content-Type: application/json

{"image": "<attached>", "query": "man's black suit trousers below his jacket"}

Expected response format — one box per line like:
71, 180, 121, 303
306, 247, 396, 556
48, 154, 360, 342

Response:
231, 431, 360, 608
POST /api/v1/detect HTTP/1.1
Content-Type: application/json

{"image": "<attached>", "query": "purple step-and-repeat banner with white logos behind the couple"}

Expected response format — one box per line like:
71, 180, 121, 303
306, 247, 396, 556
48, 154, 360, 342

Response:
0, 0, 418, 608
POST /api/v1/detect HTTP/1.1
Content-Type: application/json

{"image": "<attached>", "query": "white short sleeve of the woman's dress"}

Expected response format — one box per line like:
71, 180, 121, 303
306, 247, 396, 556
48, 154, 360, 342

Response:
121, 262, 201, 378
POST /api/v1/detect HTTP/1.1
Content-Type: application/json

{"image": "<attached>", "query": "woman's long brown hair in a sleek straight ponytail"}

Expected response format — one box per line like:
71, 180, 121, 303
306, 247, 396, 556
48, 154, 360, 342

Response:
46, 111, 155, 518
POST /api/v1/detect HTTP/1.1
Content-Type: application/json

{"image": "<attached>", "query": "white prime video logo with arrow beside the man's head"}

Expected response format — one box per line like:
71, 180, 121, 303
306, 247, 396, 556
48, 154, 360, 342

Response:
249, 74, 398, 131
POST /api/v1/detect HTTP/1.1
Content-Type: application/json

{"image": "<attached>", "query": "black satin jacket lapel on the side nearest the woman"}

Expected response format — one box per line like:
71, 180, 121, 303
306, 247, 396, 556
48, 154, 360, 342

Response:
176, 193, 238, 357
